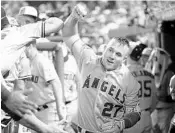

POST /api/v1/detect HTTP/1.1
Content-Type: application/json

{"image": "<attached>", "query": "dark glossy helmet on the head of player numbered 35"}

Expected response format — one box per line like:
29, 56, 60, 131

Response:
130, 43, 147, 61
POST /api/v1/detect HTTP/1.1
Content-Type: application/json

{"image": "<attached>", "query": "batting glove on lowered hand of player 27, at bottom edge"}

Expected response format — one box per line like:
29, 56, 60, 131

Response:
102, 120, 125, 133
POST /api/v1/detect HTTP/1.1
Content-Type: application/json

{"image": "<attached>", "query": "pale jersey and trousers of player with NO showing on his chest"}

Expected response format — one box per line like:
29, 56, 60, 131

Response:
27, 53, 59, 123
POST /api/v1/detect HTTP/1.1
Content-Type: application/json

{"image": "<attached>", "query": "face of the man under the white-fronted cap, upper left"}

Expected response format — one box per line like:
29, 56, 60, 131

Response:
18, 16, 35, 25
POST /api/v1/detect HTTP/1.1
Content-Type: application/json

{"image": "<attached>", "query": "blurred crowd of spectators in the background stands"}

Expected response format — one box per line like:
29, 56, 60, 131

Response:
2, 1, 160, 52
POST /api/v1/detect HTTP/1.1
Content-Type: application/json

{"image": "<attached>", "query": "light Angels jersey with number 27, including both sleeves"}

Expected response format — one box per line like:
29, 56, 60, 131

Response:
64, 36, 139, 132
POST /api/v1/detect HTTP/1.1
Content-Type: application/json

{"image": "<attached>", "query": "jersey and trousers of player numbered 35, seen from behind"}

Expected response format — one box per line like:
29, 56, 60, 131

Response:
124, 64, 156, 133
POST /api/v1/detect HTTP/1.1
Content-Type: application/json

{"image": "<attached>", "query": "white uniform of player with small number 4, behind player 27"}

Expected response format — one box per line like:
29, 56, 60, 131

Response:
62, 42, 80, 122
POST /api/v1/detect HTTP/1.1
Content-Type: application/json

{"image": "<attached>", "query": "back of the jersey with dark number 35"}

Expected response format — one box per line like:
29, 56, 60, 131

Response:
128, 65, 156, 110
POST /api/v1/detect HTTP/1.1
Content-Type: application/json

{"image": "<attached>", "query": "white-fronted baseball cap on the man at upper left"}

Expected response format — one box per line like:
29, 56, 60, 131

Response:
18, 6, 38, 18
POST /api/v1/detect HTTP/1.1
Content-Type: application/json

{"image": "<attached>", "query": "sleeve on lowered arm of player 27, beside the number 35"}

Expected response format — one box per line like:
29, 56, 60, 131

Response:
125, 72, 140, 113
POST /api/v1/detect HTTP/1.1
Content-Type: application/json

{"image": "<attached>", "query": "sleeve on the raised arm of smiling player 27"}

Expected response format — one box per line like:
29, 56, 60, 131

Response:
63, 34, 96, 71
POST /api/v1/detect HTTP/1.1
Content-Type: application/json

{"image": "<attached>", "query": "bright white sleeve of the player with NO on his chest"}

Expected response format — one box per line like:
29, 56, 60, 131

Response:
39, 57, 58, 82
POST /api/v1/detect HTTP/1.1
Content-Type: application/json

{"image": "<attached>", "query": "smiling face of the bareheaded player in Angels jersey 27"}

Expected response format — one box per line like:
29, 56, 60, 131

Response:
103, 40, 129, 70
